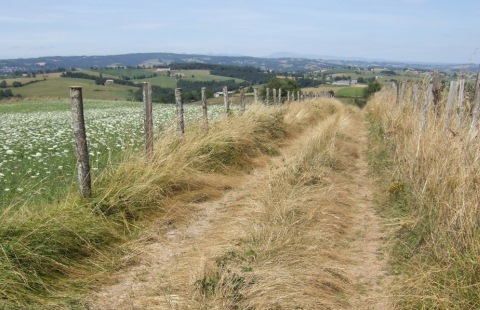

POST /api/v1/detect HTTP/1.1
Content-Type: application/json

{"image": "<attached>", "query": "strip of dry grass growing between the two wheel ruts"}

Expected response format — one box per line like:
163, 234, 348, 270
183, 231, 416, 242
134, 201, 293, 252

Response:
191, 100, 359, 309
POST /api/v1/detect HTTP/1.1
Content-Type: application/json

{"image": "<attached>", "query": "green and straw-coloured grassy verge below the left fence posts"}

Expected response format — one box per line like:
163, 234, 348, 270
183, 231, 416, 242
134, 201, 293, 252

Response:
0, 103, 332, 309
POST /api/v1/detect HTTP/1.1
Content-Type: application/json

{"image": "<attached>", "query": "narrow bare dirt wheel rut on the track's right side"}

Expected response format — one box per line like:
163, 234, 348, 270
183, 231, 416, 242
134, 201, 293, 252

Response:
340, 123, 393, 310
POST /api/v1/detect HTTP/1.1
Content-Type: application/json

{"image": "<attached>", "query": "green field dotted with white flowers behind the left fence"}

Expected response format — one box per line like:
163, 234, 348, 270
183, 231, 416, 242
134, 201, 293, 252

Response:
0, 99, 222, 209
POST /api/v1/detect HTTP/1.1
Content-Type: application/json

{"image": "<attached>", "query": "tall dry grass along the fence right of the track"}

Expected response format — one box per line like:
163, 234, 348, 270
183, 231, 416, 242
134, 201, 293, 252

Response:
367, 84, 480, 309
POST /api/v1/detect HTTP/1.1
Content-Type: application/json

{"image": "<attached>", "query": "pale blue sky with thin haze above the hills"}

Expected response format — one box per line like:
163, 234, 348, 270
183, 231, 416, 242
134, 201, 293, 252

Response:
0, 0, 480, 63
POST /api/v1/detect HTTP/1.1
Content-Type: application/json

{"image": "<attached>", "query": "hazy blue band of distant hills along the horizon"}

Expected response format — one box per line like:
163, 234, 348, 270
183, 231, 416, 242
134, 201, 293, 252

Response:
0, 53, 478, 75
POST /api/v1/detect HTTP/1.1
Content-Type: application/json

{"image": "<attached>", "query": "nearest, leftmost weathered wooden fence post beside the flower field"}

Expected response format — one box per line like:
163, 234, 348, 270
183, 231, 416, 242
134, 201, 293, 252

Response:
70, 86, 92, 198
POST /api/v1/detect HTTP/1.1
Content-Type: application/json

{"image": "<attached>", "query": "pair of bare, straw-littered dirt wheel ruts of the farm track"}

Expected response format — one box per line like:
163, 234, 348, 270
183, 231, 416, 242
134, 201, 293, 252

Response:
88, 110, 391, 310
